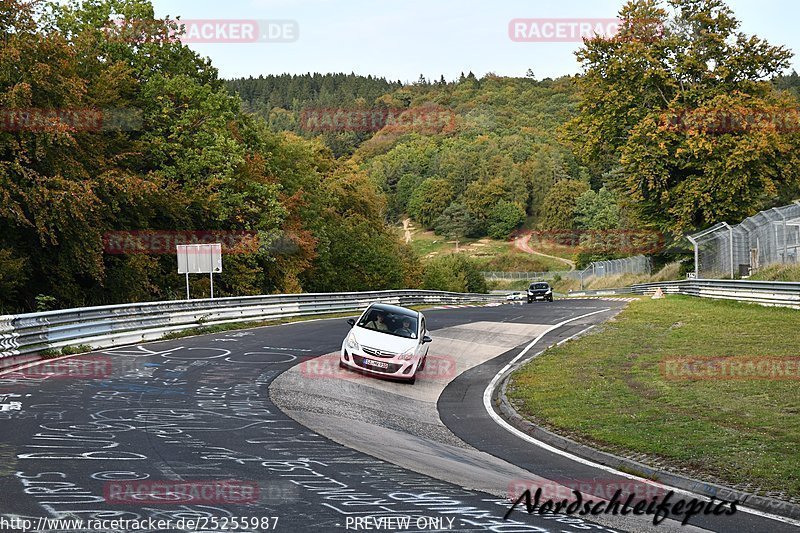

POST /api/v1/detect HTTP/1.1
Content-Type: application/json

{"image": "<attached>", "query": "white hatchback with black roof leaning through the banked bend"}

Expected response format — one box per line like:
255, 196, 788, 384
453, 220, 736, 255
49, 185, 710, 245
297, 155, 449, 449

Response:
339, 303, 431, 383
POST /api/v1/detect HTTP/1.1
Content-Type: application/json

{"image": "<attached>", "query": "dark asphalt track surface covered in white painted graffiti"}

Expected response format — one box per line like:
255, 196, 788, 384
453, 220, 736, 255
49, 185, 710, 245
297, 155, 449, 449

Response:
0, 300, 798, 532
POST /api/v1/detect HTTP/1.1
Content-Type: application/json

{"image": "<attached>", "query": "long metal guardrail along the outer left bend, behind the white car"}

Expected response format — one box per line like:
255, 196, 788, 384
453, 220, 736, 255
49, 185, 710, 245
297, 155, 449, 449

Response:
0, 290, 503, 360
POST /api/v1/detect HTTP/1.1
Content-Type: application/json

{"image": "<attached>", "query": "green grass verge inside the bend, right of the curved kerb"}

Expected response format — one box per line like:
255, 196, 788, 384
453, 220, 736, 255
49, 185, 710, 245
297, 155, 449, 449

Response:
509, 296, 800, 501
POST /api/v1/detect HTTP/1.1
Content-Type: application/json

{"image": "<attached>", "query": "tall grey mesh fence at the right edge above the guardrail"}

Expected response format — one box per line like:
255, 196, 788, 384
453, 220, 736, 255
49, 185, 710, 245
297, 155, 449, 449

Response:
688, 202, 800, 278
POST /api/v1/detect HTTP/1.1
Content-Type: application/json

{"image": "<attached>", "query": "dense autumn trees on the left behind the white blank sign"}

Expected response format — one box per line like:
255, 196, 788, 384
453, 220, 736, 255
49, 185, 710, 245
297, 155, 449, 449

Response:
0, 0, 440, 313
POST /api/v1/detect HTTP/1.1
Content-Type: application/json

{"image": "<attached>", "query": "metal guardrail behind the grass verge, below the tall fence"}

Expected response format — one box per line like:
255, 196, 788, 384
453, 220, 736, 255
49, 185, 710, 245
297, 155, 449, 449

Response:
570, 279, 800, 309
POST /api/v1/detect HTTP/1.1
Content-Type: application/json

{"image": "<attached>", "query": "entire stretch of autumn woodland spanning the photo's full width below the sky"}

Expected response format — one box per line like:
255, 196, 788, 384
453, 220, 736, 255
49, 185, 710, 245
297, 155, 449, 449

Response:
0, 0, 800, 312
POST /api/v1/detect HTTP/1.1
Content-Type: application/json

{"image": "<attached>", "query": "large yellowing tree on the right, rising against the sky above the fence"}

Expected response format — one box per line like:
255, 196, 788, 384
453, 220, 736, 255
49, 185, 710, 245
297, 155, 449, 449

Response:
569, 0, 800, 234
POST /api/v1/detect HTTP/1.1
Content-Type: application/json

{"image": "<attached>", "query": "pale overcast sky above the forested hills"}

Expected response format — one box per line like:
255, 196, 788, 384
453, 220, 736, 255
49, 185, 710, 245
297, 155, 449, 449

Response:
153, 0, 800, 82
